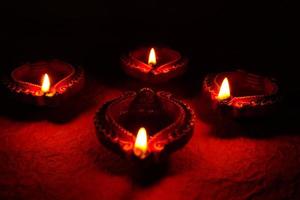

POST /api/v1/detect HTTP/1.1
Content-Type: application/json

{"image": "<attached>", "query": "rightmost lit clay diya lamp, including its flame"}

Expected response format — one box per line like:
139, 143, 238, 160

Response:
203, 70, 280, 118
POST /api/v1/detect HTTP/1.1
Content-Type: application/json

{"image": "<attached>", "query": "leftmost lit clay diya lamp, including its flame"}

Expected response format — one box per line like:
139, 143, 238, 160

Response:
3, 60, 84, 106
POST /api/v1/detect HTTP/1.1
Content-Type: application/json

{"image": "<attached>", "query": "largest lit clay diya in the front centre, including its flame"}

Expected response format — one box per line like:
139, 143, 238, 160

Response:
95, 88, 194, 160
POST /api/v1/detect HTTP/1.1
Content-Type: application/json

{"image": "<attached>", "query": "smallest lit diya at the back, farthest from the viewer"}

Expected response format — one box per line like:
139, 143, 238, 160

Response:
121, 47, 188, 83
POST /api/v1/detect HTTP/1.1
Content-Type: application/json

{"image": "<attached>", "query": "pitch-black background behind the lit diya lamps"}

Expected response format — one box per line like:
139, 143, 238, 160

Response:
0, 0, 298, 88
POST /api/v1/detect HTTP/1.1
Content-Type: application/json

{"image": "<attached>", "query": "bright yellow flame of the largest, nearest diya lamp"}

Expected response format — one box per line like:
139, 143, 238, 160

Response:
133, 127, 148, 159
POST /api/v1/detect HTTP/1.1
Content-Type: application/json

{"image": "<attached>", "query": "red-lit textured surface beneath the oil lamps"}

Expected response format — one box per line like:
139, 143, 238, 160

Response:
0, 78, 300, 200
